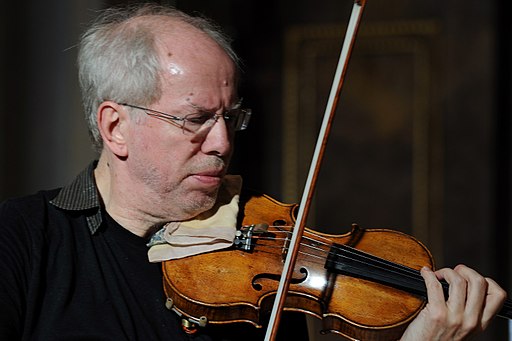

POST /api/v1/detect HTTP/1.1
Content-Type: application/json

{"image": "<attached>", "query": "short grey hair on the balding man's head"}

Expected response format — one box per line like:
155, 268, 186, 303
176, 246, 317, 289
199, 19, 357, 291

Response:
78, 4, 240, 152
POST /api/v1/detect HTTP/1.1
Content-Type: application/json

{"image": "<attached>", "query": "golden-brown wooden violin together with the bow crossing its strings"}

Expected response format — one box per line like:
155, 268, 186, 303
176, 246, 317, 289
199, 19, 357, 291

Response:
162, 0, 512, 341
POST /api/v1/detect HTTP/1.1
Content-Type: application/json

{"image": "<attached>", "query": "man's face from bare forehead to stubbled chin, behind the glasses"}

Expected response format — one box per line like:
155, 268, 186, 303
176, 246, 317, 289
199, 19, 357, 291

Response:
126, 23, 238, 220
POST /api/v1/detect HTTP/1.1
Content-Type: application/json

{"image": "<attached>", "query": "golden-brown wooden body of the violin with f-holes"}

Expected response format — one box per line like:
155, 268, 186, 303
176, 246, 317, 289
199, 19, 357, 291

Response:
163, 192, 433, 340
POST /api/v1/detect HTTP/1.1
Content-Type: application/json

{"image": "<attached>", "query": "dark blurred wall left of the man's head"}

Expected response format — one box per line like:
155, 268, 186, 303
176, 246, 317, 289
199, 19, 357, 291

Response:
0, 0, 100, 198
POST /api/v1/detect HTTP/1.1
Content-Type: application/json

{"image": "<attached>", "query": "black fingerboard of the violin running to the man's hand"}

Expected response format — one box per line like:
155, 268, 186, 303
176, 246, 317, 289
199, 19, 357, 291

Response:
325, 244, 512, 319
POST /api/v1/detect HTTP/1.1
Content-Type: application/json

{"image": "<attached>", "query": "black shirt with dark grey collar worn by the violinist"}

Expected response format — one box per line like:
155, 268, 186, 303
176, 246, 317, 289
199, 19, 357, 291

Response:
0, 163, 307, 341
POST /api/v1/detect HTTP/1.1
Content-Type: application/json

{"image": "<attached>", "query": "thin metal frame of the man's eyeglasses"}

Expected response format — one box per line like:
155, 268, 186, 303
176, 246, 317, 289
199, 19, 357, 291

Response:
119, 100, 252, 134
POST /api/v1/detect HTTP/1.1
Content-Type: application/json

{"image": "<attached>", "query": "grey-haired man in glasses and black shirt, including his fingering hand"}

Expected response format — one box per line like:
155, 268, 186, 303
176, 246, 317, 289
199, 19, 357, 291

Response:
0, 6, 505, 340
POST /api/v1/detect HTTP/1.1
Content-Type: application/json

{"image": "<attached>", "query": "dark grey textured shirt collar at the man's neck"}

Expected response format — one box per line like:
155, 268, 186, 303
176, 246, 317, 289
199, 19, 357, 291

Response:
50, 161, 102, 233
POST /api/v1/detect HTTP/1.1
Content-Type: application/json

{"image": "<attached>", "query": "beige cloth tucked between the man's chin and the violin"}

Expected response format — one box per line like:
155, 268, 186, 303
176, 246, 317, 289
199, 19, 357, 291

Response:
148, 175, 242, 263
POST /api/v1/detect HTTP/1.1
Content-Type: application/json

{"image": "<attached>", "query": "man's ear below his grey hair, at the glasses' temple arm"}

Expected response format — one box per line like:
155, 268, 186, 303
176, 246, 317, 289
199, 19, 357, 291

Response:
96, 101, 129, 158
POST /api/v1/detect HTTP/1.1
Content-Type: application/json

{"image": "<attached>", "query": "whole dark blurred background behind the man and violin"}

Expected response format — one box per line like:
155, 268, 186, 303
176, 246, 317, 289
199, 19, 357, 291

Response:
0, 0, 512, 340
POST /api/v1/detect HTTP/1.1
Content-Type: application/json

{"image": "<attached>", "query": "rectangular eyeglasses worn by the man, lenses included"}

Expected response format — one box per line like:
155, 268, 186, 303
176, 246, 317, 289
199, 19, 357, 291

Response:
119, 103, 252, 134
